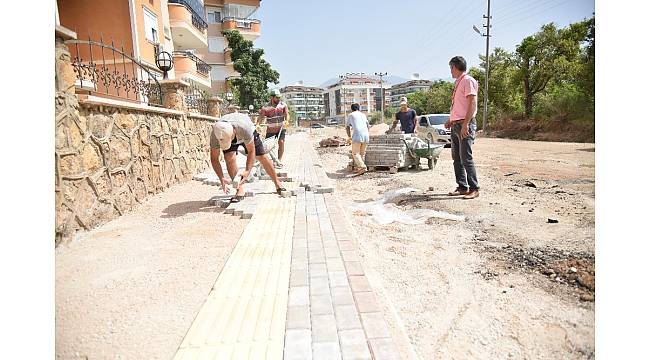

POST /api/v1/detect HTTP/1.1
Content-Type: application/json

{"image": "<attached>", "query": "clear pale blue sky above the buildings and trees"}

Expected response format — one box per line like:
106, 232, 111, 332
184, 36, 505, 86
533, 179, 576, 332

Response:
253, 0, 594, 87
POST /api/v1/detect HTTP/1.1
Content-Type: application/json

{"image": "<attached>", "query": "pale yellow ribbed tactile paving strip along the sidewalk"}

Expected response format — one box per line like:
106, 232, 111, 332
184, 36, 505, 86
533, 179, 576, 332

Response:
174, 195, 296, 360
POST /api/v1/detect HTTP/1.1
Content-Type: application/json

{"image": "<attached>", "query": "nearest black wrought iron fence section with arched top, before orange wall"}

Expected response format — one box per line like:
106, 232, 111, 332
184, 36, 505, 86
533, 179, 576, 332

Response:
66, 37, 162, 106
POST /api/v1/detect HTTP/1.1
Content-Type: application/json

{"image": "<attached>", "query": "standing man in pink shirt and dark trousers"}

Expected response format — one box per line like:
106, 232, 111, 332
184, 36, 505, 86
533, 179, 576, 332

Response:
445, 56, 479, 199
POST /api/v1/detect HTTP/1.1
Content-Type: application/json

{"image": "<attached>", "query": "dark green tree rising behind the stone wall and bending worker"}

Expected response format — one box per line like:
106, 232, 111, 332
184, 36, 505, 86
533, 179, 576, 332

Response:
223, 30, 280, 109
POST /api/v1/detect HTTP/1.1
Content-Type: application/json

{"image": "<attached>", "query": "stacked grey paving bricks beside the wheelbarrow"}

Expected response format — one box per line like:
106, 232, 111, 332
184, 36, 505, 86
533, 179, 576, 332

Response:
364, 133, 416, 174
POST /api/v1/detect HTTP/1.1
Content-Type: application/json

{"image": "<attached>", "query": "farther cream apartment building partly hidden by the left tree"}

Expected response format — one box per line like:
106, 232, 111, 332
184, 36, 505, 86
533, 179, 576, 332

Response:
197, 0, 261, 94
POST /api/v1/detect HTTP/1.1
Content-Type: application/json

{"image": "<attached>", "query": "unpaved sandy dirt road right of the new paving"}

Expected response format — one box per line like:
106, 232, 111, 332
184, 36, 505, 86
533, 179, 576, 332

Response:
311, 129, 595, 359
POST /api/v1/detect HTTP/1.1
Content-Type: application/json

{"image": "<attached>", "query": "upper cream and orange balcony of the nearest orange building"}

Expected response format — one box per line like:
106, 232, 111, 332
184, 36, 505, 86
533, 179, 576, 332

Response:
168, 0, 208, 50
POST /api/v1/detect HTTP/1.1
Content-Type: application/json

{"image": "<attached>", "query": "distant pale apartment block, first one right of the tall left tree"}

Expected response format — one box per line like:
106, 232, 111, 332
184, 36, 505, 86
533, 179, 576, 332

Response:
280, 85, 325, 120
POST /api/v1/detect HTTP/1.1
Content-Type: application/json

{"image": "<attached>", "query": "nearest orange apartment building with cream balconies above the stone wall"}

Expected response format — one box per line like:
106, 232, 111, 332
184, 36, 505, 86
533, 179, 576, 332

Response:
56, 0, 212, 101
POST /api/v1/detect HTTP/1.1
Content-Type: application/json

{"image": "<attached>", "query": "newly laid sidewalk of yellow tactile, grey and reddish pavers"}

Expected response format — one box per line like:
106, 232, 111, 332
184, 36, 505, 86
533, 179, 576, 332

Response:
174, 133, 400, 359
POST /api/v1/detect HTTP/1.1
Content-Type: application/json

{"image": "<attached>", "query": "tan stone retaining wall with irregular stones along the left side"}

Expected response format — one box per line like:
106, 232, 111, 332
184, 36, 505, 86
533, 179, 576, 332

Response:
55, 92, 211, 245
